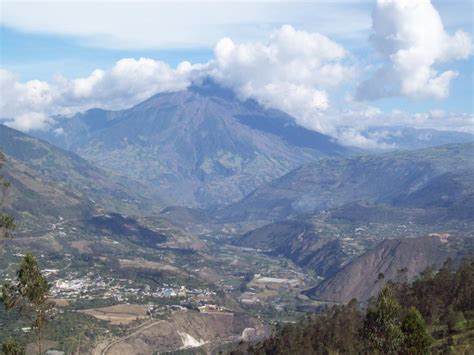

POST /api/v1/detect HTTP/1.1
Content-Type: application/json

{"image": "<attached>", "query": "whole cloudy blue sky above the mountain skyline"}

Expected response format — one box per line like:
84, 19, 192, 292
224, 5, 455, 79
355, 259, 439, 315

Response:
0, 0, 474, 147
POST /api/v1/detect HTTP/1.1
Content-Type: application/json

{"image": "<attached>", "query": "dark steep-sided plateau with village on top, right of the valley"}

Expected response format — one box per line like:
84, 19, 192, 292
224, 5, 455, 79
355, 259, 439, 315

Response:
233, 202, 473, 278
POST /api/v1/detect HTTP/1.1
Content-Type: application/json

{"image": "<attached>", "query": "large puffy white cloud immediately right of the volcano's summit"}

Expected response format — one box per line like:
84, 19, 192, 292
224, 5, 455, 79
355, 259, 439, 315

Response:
209, 25, 355, 128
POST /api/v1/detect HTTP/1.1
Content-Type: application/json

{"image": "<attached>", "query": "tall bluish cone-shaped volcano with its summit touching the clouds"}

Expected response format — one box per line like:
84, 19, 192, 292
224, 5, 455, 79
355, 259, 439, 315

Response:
37, 81, 350, 207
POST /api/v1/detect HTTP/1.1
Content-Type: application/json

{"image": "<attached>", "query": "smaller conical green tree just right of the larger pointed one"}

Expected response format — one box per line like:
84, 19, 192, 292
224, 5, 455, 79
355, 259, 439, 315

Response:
401, 307, 433, 354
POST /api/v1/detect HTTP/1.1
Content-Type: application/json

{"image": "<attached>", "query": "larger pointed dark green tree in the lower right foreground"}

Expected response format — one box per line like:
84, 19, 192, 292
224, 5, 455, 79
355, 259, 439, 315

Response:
362, 287, 404, 354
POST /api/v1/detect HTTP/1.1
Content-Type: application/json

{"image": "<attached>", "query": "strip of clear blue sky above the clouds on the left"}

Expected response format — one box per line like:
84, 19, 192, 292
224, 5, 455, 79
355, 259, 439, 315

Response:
0, 26, 212, 80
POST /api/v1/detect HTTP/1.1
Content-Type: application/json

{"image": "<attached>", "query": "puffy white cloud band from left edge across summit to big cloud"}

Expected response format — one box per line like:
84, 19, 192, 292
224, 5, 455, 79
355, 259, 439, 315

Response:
0, 26, 354, 131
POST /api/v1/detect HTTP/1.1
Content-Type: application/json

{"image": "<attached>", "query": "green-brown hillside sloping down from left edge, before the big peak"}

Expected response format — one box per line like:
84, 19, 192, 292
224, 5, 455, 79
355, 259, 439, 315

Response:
0, 125, 160, 229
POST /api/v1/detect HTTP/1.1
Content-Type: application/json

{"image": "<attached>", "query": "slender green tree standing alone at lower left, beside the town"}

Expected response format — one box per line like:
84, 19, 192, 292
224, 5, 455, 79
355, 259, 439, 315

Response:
2, 253, 51, 354
